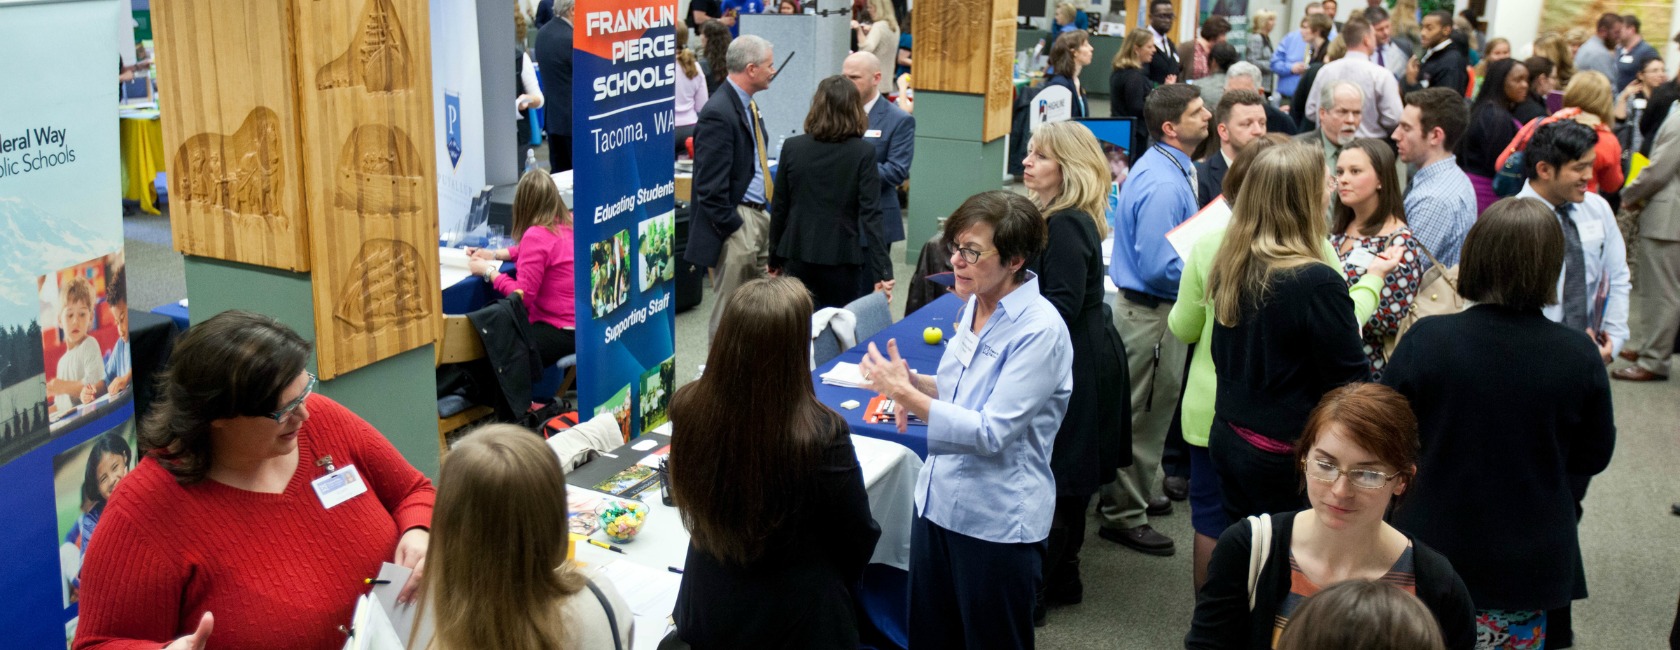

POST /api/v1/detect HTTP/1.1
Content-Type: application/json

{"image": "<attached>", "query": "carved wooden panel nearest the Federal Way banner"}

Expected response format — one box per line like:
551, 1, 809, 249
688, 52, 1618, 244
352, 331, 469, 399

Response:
153, 0, 309, 270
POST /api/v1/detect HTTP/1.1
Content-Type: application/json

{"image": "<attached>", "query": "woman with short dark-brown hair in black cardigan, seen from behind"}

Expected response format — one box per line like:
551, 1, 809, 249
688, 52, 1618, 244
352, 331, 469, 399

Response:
1383, 198, 1616, 644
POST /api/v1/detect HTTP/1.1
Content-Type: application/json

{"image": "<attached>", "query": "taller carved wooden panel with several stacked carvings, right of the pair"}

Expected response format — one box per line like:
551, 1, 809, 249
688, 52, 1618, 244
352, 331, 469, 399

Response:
292, 0, 442, 378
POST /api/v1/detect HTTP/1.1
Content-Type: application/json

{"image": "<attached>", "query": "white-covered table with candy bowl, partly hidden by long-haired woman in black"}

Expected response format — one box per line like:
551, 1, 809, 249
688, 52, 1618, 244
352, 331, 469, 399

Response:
566, 423, 922, 648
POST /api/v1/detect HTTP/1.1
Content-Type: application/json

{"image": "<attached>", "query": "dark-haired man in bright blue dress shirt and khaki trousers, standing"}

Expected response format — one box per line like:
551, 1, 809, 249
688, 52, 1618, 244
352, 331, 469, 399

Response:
1097, 84, 1211, 556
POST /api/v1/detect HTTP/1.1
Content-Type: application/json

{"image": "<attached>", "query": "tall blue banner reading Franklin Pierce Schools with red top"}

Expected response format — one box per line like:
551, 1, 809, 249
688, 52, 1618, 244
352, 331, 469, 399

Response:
571, 0, 677, 437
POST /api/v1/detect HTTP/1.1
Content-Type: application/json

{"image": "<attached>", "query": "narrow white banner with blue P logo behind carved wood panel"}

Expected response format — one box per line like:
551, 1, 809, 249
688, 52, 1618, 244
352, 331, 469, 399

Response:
430, 0, 487, 245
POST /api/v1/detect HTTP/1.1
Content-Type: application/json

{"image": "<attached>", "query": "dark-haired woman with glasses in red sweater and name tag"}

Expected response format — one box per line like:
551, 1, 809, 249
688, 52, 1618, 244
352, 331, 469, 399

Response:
74, 311, 433, 650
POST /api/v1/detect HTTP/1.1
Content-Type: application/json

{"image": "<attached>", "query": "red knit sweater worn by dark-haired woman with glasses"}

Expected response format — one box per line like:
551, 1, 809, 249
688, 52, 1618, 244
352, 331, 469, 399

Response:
76, 395, 433, 650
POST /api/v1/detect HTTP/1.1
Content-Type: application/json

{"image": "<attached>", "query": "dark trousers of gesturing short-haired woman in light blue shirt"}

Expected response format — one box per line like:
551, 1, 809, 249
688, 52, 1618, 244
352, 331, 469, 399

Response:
909, 517, 1045, 650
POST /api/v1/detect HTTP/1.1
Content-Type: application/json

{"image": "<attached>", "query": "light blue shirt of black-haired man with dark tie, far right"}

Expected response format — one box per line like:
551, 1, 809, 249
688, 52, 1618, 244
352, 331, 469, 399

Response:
1517, 181, 1633, 354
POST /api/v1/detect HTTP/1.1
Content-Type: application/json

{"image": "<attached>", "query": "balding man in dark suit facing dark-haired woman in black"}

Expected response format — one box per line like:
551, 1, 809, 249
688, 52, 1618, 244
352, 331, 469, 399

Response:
840, 52, 916, 244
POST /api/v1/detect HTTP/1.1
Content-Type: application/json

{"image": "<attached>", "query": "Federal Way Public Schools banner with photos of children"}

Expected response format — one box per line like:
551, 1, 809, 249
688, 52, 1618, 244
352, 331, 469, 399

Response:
0, 0, 136, 648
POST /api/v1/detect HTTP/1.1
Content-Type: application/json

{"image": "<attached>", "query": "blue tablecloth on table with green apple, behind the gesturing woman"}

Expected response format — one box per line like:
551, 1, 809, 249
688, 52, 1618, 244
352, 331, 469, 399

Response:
811, 294, 963, 460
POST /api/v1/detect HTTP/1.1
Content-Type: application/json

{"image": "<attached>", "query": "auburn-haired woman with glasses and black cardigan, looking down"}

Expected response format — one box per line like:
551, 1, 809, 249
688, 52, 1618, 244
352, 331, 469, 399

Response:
1184, 383, 1477, 650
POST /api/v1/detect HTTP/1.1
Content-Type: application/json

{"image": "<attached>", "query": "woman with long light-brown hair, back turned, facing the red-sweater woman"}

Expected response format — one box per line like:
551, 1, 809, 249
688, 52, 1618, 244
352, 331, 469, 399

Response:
408, 425, 632, 650
